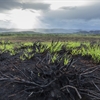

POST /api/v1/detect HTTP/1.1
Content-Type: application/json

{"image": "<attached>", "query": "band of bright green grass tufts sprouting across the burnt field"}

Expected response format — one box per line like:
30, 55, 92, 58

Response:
0, 41, 100, 64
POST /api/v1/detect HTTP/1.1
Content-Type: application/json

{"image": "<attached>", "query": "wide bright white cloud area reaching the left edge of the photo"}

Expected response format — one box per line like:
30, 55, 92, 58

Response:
0, 9, 45, 29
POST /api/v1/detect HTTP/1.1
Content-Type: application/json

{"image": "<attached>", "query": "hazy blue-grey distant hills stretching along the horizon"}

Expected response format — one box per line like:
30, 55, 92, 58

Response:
0, 28, 100, 34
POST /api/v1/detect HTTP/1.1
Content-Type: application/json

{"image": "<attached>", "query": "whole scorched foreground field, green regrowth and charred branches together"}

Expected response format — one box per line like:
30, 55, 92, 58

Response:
0, 41, 100, 100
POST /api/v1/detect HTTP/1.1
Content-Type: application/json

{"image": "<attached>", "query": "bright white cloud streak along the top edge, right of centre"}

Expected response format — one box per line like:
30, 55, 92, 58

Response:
43, 0, 94, 10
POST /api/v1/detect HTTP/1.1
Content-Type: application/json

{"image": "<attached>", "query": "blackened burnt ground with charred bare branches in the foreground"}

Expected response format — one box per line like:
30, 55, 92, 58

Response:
0, 53, 100, 100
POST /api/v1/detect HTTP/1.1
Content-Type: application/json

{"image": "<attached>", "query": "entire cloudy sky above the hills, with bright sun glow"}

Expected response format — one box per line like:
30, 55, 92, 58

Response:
0, 0, 100, 30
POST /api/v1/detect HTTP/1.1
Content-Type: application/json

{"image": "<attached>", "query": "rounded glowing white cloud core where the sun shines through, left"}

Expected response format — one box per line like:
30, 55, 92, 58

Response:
10, 9, 41, 29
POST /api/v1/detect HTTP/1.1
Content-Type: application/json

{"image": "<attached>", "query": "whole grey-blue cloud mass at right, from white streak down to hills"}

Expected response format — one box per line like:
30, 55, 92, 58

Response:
40, 2, 100, 30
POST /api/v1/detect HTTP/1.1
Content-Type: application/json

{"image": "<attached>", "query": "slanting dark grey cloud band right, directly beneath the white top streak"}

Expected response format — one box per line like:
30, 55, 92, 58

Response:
44, 2, 100, 20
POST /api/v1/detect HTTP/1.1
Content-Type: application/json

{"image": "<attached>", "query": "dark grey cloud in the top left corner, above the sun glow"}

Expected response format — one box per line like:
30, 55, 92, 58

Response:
0, 0, 50, 12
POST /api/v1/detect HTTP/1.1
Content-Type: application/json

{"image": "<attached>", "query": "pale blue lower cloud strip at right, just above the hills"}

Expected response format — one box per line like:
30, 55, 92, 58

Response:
43, 19, 100, 30
